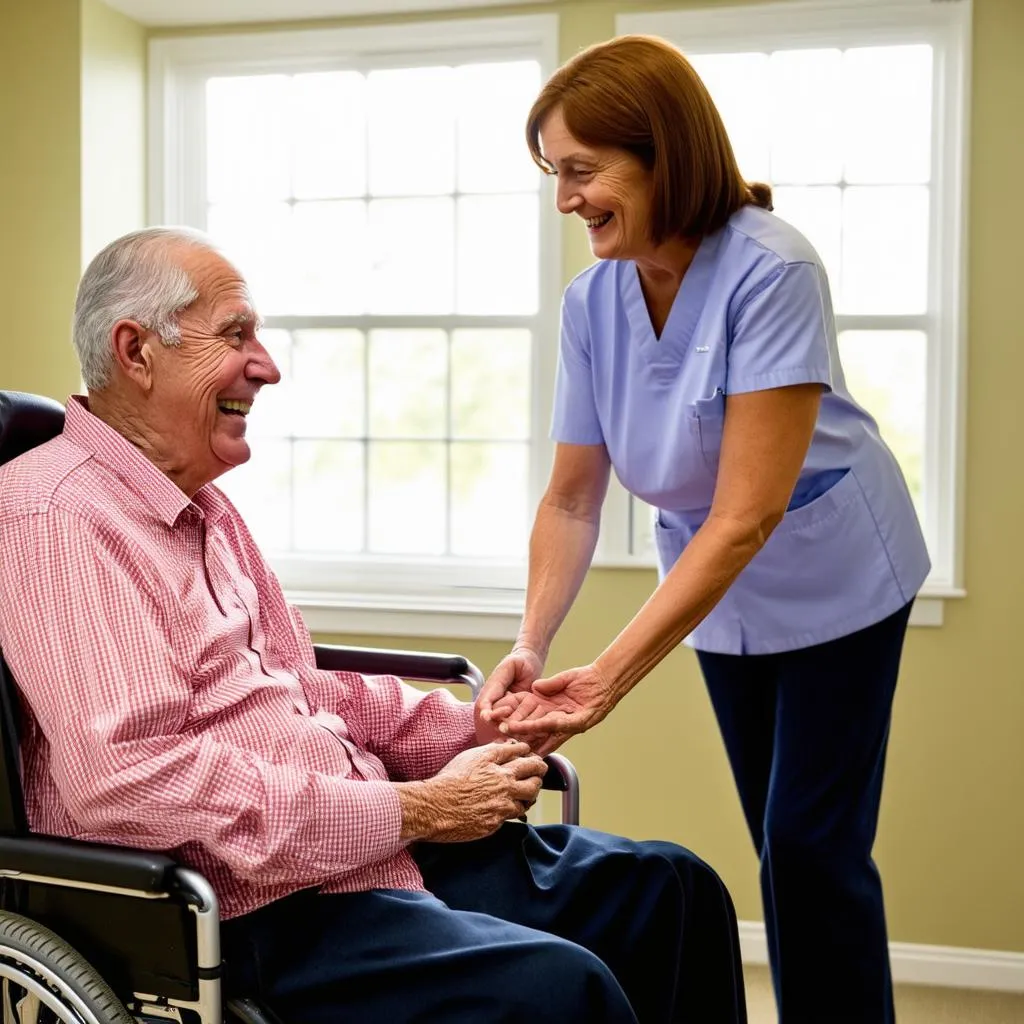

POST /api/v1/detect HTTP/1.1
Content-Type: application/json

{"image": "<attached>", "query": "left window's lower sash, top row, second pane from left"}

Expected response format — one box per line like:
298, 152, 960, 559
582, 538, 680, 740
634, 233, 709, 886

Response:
292, 330, 366, 437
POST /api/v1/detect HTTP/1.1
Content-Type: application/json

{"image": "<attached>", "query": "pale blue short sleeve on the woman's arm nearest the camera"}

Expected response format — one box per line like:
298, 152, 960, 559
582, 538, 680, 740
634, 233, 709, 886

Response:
726, 262, 833, 394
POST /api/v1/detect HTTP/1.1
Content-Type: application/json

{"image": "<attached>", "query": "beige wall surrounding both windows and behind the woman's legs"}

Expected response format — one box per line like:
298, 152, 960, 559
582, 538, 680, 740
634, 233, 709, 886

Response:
0, 0, 1024, 951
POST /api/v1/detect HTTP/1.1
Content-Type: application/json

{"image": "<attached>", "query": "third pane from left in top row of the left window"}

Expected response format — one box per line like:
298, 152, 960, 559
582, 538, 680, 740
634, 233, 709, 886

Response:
369, 68, 455, 196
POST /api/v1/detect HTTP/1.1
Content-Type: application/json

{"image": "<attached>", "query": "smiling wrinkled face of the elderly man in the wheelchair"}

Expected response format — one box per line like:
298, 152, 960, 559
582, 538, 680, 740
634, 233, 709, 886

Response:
145, 243, 281, 495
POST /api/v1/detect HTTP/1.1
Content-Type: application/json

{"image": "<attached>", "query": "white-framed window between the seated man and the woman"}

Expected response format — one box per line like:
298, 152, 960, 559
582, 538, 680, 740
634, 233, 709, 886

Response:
151, 16, 559, 636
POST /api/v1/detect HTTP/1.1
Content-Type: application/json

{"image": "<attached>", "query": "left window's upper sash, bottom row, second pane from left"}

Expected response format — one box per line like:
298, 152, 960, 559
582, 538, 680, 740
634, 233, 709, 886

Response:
290, 200, 370, 314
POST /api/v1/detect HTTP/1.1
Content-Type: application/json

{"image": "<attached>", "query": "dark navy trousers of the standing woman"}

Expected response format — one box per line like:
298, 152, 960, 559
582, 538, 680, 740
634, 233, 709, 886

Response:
698, 604, 910, 1024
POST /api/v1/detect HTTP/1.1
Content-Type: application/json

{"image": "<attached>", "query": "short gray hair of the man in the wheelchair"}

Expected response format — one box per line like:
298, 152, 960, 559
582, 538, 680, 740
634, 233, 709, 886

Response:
72, 227, 216, 391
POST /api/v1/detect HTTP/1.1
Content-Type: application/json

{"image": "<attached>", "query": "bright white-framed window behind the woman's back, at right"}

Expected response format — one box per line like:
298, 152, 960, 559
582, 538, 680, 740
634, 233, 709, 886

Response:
605, 0, 970, 614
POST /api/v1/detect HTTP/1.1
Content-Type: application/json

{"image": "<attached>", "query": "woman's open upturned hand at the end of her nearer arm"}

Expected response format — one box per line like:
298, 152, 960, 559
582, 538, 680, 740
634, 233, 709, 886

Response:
494, 665, 618, 754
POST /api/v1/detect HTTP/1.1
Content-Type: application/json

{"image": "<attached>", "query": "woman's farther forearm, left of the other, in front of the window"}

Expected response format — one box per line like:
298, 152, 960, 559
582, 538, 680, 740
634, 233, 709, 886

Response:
516, 499, 600, 659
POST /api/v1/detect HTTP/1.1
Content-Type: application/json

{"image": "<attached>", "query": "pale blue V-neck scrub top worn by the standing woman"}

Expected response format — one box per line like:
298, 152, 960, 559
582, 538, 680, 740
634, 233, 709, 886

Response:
551, 206, 930, 654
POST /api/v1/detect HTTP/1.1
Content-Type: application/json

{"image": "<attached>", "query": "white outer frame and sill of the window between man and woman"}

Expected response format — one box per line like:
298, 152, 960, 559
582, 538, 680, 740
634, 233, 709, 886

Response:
148, 14, 562, 639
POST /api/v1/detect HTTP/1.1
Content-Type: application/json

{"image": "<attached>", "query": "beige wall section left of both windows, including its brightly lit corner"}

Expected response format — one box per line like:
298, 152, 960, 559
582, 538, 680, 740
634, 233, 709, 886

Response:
0, 0, 145, 399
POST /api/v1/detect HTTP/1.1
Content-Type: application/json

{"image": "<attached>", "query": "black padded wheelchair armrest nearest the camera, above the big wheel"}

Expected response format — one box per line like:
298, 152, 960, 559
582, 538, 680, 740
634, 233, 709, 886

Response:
0, 836, 177, 895
